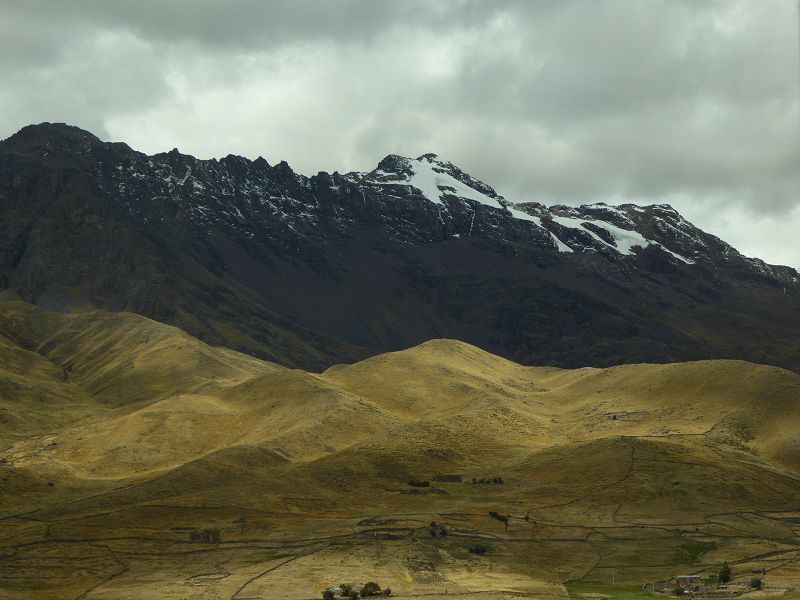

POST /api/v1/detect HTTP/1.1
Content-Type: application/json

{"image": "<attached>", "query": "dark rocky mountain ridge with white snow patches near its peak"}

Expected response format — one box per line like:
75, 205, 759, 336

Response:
0, 124, 800, 370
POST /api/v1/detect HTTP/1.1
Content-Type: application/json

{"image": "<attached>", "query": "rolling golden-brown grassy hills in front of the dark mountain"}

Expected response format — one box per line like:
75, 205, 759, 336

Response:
0, 302, 800, 600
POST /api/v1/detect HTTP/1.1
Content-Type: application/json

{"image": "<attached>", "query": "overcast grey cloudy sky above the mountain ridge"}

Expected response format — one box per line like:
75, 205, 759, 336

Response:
0, 0, 800, 267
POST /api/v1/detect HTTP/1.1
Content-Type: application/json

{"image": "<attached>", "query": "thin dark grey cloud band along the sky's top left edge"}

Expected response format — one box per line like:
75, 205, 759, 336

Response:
5, 0, 456, 50
